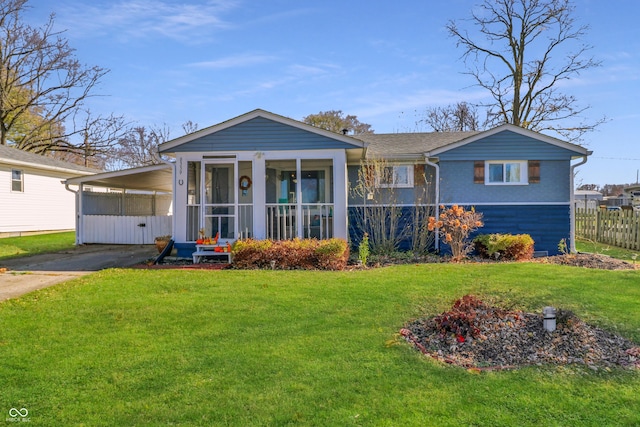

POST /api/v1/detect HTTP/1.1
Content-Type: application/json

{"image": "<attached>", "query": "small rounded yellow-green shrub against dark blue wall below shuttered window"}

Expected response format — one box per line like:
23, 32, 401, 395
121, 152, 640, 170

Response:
473, 234, 534, 261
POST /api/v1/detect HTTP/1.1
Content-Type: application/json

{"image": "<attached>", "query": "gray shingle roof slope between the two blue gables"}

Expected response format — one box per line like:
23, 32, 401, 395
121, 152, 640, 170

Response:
353, 131, 480, 157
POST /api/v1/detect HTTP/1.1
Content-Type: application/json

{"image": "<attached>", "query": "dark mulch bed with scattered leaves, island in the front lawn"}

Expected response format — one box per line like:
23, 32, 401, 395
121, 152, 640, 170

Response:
400, 298, 640, 370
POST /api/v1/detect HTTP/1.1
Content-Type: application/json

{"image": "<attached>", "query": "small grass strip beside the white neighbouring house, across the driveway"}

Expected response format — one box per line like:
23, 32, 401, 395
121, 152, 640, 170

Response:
0, 231, 76, 260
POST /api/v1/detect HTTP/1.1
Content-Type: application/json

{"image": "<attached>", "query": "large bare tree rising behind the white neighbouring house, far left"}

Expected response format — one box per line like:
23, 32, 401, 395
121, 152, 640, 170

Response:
0, 0, 108, 153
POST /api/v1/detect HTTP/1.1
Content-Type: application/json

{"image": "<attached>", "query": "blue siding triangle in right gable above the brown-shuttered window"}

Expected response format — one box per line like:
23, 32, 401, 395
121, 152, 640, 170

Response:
439, 131, 577, 160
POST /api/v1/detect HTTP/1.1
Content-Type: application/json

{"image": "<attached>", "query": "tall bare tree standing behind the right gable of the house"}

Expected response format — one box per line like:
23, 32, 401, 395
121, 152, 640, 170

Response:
447, 0, 604, 140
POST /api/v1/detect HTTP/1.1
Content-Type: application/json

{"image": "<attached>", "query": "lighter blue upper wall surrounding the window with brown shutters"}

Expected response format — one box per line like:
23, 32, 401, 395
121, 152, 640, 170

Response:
440, 158, 571, 204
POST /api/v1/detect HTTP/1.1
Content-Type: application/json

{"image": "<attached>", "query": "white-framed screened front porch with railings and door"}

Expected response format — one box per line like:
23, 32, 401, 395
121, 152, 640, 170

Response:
185, 158, 338, 242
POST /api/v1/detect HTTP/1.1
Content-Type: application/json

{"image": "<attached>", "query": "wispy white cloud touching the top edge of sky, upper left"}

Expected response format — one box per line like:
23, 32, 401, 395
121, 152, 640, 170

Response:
58, 0, 238, 40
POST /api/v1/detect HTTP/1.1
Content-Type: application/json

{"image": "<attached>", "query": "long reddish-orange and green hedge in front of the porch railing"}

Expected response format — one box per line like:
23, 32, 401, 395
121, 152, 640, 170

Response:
233, 239, 349, 270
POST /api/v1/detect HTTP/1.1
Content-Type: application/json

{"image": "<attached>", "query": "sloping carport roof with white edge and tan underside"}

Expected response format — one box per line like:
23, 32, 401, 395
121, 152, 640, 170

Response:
65, 164, 173, 193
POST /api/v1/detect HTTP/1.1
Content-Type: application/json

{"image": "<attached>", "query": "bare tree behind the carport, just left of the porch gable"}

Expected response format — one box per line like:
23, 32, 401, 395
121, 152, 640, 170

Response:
108, 125, 169, 170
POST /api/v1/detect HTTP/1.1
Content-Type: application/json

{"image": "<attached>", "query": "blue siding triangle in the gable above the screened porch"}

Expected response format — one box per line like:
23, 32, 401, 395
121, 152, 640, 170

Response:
172, 117, 354, 152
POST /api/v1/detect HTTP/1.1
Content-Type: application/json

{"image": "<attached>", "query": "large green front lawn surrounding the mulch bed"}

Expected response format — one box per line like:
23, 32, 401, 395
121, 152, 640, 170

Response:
0, 263, 640, 427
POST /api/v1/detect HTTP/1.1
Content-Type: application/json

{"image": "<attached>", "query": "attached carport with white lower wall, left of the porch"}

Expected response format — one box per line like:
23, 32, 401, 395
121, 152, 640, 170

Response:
64, 164, 174, 245
